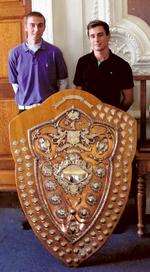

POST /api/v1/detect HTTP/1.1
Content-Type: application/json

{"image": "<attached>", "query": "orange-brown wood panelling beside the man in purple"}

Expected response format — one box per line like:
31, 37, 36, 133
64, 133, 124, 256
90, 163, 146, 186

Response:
0, 0, 31, 190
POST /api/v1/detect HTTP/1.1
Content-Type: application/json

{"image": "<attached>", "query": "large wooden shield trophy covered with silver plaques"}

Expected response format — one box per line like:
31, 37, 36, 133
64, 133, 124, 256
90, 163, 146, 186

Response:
10, 89, 136, 266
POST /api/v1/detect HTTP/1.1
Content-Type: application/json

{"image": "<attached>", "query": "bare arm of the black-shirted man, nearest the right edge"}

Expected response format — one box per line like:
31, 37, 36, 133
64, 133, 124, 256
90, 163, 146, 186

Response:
120, 88, 134, 111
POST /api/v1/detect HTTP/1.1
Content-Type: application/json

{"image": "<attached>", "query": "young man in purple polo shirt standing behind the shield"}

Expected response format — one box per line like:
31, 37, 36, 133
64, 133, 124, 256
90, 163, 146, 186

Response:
8, 11, 68, 111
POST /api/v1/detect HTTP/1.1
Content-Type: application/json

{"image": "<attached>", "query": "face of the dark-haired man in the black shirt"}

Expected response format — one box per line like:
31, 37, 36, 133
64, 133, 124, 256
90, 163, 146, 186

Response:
89, 26, 110, 52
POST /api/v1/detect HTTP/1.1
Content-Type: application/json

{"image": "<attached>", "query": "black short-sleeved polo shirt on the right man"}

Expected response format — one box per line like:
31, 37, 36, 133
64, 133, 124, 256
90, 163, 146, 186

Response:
73, 51, 134, 107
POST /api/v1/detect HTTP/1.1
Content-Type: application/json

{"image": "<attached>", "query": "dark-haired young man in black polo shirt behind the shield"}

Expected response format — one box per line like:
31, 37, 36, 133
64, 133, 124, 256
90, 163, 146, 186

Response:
73, 20, 134, 111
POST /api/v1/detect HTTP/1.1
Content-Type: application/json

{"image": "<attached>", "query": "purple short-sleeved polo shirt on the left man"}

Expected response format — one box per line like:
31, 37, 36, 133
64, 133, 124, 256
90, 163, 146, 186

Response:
8, 40, 68, 106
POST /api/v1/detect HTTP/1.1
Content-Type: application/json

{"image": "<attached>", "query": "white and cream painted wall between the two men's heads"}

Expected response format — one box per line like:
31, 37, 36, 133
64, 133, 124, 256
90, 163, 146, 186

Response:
32, 0, 83, 87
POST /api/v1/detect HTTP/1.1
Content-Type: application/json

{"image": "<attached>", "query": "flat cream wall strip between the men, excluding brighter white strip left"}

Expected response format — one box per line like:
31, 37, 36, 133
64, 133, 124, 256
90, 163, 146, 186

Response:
53, 0, 83, 86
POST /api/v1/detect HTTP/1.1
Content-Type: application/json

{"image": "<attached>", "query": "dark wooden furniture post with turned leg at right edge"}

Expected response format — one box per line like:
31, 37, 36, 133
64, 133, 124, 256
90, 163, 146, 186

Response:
134, 75, 150, 237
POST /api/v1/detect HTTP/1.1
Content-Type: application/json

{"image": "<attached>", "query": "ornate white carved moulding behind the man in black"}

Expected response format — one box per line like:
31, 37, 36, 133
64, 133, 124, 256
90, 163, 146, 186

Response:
90, 0, 150, 75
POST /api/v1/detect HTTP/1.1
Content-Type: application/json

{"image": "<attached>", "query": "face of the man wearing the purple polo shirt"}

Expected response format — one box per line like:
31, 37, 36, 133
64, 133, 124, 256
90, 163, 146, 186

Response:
25, 16, 45, 42
